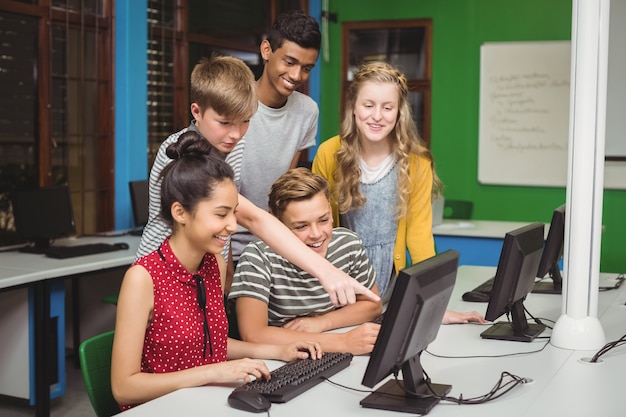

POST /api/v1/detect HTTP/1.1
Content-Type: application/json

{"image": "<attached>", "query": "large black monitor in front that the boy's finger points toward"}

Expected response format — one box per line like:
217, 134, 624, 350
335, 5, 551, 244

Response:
361, 250, 459, 414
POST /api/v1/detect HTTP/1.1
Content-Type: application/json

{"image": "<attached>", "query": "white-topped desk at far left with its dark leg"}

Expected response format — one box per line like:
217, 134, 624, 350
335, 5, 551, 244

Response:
0, 235, 140, 417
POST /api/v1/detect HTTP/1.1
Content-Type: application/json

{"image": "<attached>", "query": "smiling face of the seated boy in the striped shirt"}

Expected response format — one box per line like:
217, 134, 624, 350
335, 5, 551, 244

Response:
280, 192, 333, 257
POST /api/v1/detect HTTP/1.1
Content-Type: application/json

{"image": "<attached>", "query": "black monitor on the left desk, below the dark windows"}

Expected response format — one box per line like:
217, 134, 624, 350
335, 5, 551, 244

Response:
12, 186, 76, 253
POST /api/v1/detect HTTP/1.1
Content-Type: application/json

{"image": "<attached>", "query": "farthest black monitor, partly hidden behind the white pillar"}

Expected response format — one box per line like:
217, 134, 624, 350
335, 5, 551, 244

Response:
533, 204, 565, 294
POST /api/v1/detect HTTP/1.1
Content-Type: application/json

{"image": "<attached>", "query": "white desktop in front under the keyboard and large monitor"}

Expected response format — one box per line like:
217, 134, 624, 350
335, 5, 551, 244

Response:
121, 266, 626, 417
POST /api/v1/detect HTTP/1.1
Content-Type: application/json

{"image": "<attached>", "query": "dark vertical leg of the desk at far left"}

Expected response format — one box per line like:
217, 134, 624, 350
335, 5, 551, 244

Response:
33, 279, 50, 417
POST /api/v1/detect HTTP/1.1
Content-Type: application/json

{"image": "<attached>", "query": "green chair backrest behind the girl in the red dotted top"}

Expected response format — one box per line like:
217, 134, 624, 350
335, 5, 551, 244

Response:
78, 331, 120, 417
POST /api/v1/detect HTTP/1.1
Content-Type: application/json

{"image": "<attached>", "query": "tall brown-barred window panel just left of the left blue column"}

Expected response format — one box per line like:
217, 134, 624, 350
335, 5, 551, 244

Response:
50, 26, 104, 234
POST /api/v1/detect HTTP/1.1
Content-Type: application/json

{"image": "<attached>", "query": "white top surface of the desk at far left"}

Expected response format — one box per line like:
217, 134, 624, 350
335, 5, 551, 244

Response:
0, 235, 141, 289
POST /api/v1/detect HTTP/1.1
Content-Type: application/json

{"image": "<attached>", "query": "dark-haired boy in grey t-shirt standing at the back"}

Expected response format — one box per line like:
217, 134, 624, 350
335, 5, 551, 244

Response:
227, 10, 321, 272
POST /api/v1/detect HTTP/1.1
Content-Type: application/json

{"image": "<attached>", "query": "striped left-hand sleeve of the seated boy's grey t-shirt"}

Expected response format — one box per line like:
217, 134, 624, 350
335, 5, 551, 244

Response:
228, 242, 272, 304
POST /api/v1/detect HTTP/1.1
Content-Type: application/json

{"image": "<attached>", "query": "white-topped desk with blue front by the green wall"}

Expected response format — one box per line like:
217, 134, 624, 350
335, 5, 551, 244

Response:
433, 219, 550, 266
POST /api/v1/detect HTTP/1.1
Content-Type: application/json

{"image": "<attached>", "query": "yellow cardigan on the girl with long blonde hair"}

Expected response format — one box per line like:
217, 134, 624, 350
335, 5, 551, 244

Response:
312, 136, 435, 273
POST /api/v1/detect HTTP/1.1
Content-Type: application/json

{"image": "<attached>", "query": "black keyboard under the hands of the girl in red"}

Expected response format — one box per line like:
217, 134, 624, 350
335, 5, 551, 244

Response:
235, 352, 352, 403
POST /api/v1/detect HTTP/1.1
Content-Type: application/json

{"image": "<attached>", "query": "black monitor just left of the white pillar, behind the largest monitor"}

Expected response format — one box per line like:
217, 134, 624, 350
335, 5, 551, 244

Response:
480, 223, 545, 342
